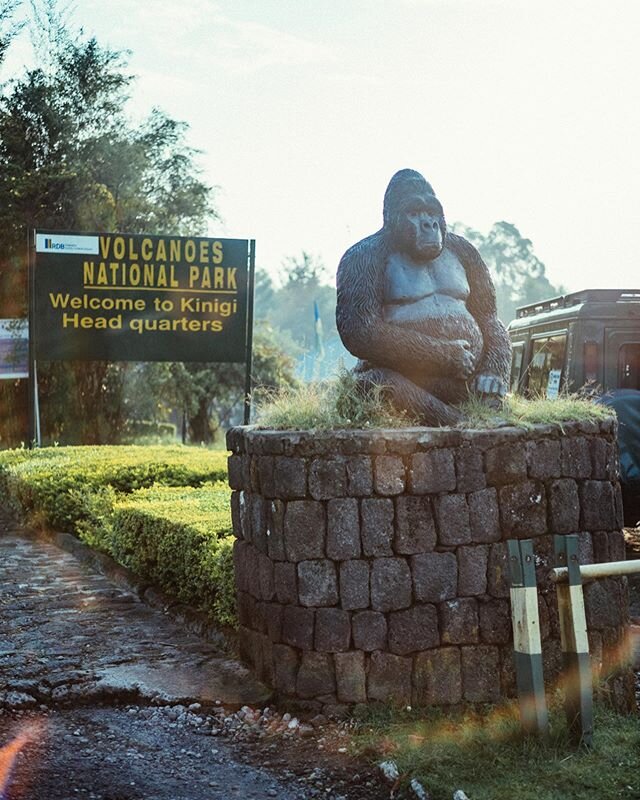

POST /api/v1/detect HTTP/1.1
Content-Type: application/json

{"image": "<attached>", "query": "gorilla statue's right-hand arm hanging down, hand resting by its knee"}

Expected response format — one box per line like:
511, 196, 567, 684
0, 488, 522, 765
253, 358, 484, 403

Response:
447, 233, 511, 396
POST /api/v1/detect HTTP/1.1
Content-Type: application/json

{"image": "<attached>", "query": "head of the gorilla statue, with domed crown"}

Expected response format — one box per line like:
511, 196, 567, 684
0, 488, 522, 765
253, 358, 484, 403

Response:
384, 170, 446, 262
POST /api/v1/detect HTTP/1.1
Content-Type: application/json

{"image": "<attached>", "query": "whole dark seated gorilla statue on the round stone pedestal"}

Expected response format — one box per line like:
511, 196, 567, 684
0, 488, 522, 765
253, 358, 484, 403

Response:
336, 169, 511, 425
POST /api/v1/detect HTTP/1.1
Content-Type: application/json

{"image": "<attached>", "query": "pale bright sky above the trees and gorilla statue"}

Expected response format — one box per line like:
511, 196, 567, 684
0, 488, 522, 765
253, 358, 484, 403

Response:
0, 0, 640, 291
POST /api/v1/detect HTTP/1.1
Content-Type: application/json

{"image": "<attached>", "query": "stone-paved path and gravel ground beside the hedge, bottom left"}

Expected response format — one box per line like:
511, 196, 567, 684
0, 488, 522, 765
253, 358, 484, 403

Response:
0, 515, 388, 800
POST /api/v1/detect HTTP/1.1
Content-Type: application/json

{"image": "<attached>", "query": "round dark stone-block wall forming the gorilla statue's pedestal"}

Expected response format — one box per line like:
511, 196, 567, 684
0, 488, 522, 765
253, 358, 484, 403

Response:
227, 420, 627, 707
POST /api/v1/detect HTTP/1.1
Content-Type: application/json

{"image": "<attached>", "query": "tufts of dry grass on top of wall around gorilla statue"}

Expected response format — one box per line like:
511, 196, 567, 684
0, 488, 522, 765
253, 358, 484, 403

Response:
255, 370, 612, 430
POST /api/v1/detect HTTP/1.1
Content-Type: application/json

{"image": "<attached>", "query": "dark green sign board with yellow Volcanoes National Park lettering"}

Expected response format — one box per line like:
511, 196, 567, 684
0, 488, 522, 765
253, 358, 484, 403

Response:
32, 231, 253, 362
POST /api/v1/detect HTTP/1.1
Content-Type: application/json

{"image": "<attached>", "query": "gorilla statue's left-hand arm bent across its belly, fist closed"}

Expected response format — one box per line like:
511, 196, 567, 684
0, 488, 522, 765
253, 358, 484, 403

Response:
336, 229, 476, 377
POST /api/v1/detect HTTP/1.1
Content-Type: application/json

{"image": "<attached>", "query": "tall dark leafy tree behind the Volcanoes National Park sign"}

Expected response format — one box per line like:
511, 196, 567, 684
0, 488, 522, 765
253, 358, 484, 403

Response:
0, 0, 216, 442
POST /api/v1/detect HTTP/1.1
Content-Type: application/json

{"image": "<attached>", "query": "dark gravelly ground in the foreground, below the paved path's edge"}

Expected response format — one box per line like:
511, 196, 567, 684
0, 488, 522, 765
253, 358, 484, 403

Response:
0, 707, 389, 800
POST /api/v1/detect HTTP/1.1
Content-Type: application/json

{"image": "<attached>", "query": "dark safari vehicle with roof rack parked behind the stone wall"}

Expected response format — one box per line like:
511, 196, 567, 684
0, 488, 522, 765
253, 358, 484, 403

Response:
508, 289, 640, 525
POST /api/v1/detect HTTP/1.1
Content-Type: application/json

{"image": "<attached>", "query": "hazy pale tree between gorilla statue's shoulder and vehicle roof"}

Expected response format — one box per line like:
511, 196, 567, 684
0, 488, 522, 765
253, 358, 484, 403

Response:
453, 221, 565, 324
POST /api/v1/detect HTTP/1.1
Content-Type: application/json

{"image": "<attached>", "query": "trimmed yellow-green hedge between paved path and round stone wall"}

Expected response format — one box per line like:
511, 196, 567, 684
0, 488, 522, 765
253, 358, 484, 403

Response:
0, 446, 236, 625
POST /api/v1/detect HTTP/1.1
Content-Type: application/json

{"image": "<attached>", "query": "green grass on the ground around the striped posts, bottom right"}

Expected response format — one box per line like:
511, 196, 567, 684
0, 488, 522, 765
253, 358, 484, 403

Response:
352, 705, 640, 800
